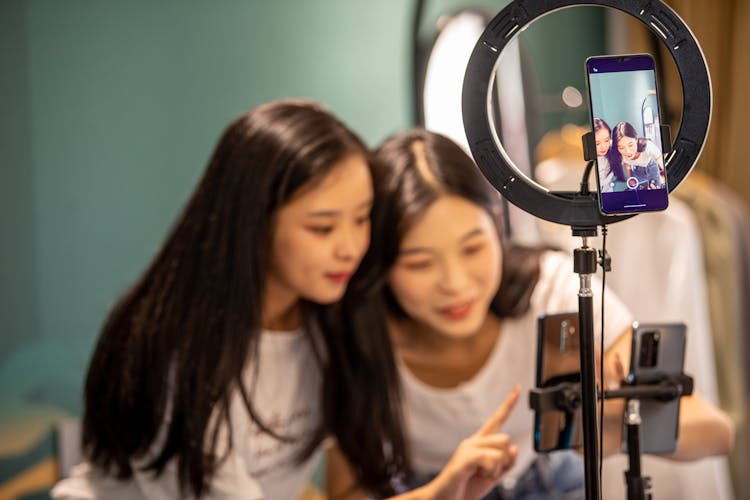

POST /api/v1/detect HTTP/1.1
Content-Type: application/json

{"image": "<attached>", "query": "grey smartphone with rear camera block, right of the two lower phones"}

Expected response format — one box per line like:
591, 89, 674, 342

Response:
622, 323, 687, 454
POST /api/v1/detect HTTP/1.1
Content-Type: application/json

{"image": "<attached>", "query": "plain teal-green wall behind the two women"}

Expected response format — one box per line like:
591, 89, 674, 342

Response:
0, 0, 604, 494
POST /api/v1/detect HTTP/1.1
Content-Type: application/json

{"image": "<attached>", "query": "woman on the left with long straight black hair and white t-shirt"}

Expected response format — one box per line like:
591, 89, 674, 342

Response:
52, 100, 524, 500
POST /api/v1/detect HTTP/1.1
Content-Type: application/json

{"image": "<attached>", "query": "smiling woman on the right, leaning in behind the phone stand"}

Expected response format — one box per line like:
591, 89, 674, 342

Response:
328, 130, 732, 499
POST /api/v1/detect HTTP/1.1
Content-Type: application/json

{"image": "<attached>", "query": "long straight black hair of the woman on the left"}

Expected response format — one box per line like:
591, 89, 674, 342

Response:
83, 100, 406, 496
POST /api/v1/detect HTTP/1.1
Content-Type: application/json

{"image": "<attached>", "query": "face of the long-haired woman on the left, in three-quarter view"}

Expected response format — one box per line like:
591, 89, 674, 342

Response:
267, 154, 373, 304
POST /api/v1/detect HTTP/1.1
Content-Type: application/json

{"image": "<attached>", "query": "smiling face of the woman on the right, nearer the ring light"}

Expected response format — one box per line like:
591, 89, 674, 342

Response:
389, 195, 502, 338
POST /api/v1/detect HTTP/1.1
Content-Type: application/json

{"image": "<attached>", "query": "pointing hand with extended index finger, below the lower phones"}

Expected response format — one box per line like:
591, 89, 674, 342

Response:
420, 386, 520, 500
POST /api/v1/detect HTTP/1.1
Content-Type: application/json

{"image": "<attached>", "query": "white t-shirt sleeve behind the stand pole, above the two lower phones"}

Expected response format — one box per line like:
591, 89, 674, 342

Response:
531, 252, 633, 348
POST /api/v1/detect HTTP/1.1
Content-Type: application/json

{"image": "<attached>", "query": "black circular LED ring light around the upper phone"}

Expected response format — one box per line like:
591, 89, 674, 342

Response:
462, 0, 711, 227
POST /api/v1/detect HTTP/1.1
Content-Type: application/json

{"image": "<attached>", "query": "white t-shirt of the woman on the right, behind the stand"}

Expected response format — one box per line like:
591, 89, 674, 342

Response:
398, 252, 632, 486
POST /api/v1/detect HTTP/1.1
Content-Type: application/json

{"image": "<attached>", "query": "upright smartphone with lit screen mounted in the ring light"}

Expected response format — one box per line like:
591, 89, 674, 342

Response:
586, 54, 669, 215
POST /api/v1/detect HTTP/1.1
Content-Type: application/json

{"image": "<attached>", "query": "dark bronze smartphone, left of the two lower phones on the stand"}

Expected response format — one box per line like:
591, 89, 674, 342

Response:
534, 312, 583, 452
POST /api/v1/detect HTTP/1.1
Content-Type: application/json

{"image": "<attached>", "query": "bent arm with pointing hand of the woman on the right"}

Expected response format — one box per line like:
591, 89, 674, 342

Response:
326, 387, 519, 500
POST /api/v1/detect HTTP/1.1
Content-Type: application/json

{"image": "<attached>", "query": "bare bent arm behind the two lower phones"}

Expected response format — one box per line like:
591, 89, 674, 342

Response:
602, 328, 734, 461
